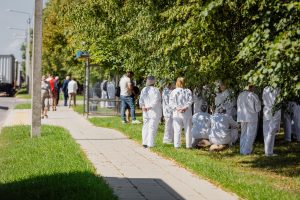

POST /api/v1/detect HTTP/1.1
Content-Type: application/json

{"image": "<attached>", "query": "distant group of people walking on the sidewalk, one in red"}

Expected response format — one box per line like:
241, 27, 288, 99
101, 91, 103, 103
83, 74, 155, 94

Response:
41, 74, 78, 119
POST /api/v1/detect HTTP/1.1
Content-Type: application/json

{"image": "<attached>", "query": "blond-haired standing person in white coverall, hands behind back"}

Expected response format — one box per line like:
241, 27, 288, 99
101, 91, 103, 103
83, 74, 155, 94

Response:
170, 77, 193, 148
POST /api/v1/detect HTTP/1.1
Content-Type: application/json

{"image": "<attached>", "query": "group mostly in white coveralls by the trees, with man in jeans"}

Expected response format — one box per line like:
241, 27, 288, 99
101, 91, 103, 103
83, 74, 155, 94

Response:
129, 73, 300, 156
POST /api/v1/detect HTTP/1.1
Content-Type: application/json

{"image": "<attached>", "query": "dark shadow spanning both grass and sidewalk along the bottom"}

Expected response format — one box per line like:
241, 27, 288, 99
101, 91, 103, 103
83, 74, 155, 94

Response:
0, 172, 184, 200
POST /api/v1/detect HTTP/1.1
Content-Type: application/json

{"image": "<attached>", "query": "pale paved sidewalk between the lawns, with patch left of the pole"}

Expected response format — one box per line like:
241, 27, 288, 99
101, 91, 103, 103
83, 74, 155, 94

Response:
1, 107, 238, 200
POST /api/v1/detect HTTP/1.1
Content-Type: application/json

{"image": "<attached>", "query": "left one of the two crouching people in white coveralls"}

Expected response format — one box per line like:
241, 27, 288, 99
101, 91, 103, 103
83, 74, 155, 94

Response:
192, 104, 210, 147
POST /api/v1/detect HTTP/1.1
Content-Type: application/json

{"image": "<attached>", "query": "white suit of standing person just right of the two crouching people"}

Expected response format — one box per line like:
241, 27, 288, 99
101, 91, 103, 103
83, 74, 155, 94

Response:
237, 91, 261, 154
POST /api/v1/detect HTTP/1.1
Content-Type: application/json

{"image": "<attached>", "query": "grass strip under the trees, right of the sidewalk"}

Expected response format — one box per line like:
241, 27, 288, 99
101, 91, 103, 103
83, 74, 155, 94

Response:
90, 117, 300, 200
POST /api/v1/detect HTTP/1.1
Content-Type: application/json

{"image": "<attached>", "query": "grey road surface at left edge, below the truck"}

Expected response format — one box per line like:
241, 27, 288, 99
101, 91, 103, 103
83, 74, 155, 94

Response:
0, 97, 30, 127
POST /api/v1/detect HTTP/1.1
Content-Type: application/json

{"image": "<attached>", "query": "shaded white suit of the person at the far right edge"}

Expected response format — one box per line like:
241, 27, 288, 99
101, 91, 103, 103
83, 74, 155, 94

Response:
284, 101, 300, 142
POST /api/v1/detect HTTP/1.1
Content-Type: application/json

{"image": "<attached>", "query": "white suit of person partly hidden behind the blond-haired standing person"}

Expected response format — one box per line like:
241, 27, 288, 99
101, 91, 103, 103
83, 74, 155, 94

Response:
162, 87, 174, 143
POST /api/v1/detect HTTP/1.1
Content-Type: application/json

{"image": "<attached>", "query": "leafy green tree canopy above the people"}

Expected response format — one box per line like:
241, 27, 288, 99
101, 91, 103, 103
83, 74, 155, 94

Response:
43, 0, 300, 100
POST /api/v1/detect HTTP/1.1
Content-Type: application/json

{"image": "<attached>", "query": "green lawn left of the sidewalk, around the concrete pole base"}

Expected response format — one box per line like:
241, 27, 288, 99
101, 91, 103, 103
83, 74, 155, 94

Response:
0, 126, 117, 200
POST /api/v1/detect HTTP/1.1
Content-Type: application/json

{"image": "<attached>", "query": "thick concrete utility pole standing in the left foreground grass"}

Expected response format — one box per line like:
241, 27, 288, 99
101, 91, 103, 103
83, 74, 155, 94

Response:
31, 0, 43, 137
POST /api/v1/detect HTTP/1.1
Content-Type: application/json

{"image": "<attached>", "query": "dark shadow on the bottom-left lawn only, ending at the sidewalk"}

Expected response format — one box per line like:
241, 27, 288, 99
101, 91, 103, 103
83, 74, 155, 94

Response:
0, 172, 117, 200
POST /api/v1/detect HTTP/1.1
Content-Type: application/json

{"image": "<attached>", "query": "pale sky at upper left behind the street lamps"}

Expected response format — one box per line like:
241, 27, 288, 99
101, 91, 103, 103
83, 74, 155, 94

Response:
0, 0, 46, 60
